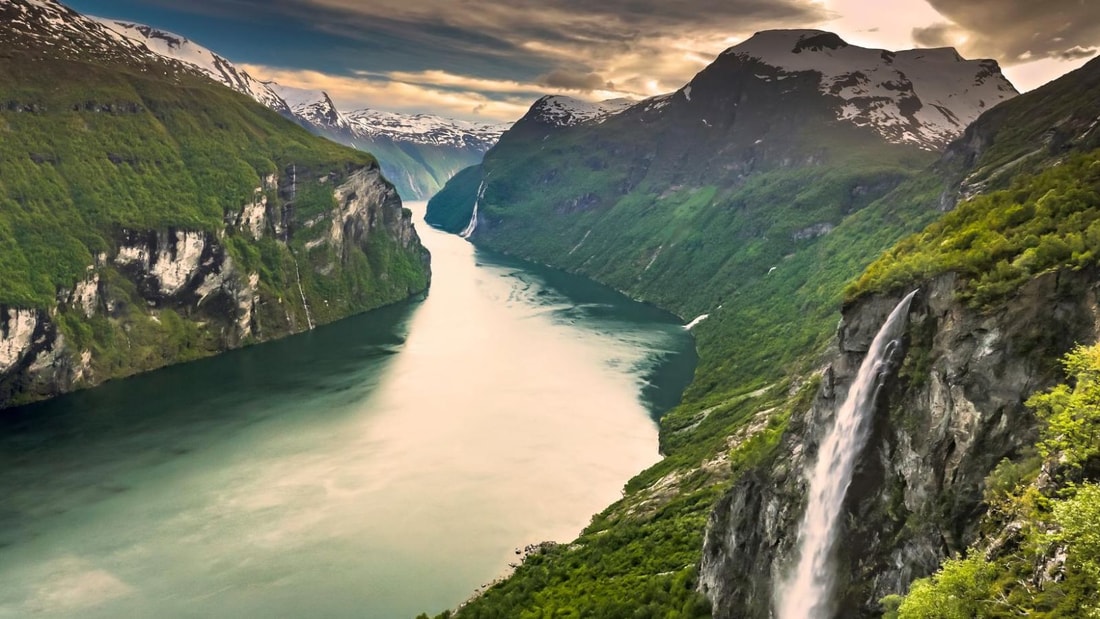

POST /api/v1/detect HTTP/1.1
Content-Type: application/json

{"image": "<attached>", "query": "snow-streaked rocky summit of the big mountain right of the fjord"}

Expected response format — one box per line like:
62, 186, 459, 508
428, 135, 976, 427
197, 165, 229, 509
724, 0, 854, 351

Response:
499, 30, 1018, 151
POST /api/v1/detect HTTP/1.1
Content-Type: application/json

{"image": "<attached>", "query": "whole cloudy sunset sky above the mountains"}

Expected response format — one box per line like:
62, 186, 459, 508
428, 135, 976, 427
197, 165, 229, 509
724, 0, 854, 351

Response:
63, 0, 1100, 122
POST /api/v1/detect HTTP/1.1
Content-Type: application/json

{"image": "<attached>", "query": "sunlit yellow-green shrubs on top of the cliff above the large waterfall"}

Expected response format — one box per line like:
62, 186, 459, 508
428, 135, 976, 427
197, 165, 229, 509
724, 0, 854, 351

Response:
846, 151, 1100, 307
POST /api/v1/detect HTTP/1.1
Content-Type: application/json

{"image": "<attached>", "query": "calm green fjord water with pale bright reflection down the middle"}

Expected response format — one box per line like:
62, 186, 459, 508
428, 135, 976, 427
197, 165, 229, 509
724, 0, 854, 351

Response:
0, 203, 695, 619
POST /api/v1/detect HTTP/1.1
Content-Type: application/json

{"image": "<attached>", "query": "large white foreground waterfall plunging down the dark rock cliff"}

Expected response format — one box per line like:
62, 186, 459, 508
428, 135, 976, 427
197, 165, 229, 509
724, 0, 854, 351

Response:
776, 290, 916, 619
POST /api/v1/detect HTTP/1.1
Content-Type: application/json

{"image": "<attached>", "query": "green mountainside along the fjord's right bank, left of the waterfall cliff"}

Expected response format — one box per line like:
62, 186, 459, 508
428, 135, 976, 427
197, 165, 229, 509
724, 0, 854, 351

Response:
422, 89, 943, 617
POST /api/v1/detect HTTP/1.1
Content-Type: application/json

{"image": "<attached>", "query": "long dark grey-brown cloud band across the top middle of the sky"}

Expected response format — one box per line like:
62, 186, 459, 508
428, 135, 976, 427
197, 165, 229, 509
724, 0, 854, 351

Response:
118, 0, 825, 79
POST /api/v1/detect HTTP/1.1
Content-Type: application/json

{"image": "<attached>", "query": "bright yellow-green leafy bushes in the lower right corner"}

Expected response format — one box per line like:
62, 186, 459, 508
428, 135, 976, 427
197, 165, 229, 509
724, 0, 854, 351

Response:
883, 345, 1100, 619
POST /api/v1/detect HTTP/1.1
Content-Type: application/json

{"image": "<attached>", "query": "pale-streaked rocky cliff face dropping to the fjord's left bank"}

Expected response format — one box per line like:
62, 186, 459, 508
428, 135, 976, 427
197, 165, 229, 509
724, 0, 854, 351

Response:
0, 166, 428, 408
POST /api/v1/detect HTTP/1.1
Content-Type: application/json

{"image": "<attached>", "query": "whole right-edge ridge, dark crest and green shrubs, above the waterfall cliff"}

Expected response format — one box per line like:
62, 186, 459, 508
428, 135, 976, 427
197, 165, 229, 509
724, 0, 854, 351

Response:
846, 56, 1100, 306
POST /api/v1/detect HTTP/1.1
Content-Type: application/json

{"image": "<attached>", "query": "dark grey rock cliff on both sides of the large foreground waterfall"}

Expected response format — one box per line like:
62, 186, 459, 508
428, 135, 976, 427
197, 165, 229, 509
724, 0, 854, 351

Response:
700, 267, 1100, 618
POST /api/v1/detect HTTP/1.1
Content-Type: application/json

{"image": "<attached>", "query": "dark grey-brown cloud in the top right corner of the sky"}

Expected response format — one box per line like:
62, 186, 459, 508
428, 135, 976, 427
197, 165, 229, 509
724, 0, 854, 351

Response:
913, 0, 1100, 65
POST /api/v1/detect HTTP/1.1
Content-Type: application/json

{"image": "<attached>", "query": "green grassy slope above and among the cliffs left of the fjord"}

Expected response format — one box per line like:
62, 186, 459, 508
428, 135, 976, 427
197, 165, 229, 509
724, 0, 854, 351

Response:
0, 41, 427, 404
